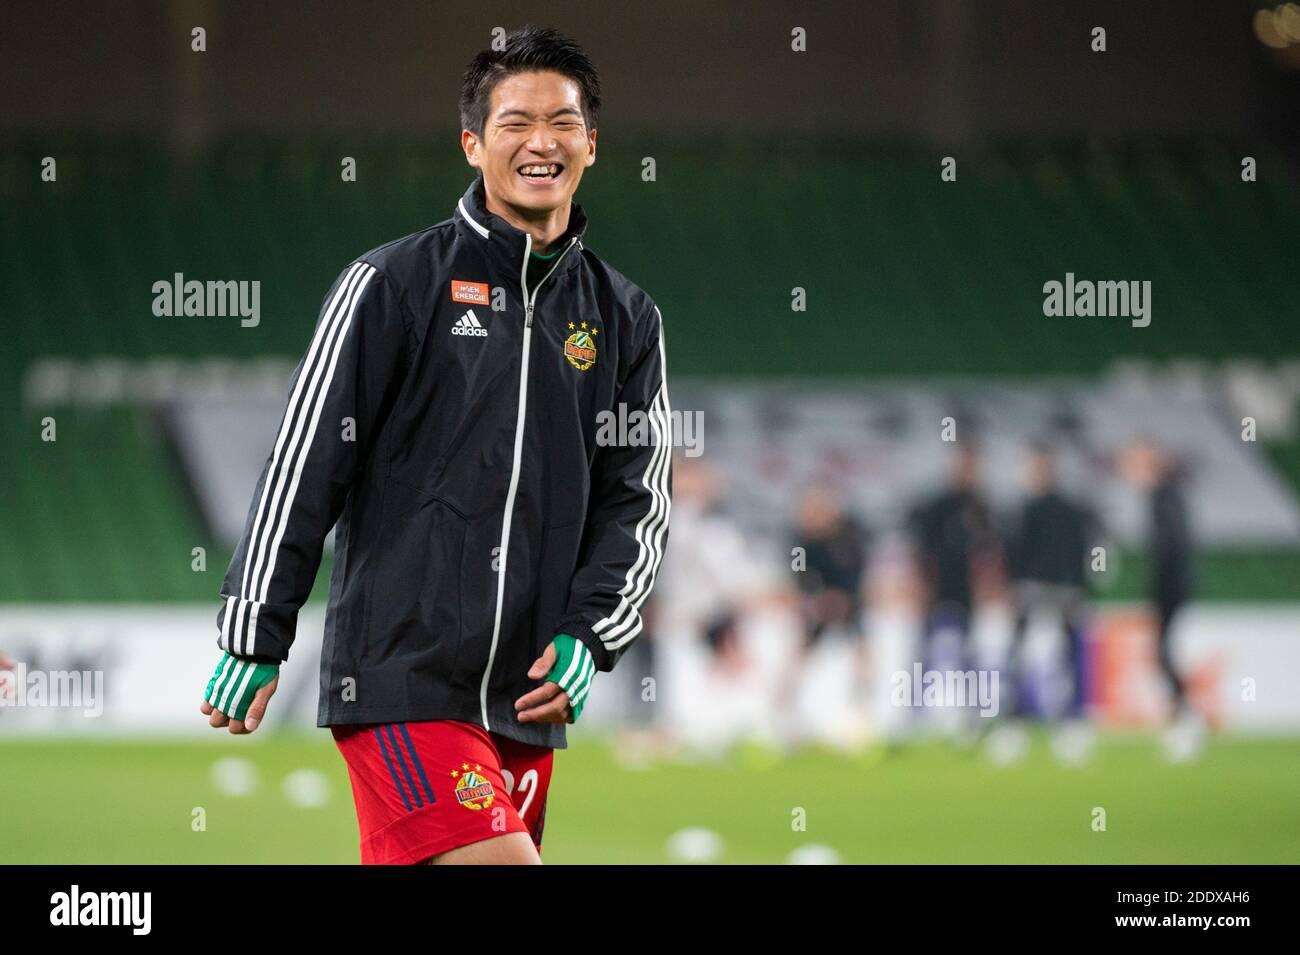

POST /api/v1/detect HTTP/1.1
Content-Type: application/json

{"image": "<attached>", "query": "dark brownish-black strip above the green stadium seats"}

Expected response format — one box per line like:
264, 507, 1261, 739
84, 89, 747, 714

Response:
0, 0, 1297, 146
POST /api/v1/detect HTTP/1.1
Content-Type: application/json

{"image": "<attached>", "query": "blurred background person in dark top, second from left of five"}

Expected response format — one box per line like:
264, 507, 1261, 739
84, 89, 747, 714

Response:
777, 482, 868, 747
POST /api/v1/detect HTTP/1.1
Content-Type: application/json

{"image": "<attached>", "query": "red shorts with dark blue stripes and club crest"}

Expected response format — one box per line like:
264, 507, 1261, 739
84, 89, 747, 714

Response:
332, 720, 554, 865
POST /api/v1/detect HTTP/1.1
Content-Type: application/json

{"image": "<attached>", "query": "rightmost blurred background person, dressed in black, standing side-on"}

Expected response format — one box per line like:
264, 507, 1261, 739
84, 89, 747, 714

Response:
1119, 438, 1205, 761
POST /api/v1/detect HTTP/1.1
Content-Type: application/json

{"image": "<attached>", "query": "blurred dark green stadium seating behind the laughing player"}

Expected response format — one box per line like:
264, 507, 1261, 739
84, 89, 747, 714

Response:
0, 139, 1300, 600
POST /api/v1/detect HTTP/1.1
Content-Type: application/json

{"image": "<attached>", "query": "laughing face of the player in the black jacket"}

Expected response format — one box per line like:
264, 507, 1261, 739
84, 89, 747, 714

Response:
460, 71, 595, 217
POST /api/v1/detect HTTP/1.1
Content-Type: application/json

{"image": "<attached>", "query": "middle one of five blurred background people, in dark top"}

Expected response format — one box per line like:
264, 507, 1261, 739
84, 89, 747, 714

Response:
907, 440, 1001, 738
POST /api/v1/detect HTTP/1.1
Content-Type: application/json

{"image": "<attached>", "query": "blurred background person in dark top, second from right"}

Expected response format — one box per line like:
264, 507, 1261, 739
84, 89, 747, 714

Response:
989, 444, 1101, 763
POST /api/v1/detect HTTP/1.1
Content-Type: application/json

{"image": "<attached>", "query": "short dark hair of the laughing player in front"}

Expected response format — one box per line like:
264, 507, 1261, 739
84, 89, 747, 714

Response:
460, 26, 601, 136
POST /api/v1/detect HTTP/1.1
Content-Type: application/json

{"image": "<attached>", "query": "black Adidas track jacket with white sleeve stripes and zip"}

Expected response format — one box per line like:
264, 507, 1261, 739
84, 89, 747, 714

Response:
217, 177, 672, 747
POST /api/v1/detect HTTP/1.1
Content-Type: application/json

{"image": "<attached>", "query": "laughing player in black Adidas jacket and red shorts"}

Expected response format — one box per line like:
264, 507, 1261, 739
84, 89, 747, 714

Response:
202, 29, 672, 863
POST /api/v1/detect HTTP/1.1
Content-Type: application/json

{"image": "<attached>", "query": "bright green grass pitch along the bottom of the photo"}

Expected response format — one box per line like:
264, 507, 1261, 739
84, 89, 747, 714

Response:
0, 733, 1300, 864
